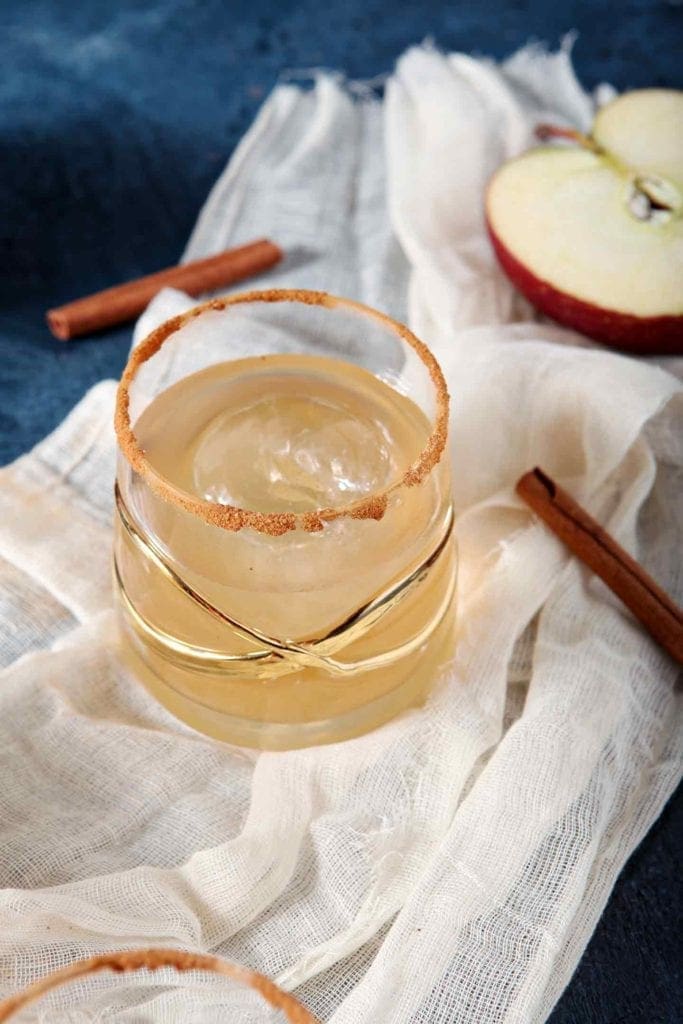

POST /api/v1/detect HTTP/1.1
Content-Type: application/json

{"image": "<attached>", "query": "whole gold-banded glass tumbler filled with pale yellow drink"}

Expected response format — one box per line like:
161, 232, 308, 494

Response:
114, 290, 456, 750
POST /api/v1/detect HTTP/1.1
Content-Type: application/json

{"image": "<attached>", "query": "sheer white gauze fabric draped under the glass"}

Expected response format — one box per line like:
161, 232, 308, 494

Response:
0, 41, 683, 1024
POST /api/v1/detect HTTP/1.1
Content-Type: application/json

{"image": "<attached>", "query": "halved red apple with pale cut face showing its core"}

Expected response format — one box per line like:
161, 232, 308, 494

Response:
486, 89, 683, 354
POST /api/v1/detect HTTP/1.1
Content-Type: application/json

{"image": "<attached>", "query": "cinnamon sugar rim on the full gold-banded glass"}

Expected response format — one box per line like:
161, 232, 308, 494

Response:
114, 289, 450, 537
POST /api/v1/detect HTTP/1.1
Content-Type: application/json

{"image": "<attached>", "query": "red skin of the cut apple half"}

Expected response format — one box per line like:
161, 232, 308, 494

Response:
486, 220, 683, 355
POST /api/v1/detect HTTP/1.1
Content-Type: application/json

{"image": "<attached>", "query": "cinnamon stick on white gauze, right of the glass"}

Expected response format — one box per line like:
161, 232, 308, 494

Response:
517, 467, 683, 663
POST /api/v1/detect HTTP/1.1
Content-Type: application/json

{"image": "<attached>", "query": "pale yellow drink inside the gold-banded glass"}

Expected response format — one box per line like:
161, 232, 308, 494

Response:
116, 354, 455, 748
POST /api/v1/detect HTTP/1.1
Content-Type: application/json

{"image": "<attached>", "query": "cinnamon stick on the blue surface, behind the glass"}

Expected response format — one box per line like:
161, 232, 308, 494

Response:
46, 239, 283, 341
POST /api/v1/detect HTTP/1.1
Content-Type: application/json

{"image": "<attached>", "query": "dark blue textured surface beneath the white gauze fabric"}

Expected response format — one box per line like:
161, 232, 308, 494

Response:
0, 0, 683, 1024
